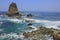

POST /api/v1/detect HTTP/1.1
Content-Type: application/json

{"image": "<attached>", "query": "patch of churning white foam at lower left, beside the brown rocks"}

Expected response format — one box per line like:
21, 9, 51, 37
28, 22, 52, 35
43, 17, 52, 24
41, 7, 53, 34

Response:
0, 33, 24, 39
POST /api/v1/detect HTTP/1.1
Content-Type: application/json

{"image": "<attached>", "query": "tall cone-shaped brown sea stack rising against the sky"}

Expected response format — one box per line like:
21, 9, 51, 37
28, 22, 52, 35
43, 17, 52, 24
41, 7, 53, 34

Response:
7, 2, 19, 16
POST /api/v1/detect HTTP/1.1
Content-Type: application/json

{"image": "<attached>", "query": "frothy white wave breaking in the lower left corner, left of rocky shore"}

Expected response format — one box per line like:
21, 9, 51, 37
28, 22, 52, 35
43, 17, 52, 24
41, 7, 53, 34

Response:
0, 32, 24, 40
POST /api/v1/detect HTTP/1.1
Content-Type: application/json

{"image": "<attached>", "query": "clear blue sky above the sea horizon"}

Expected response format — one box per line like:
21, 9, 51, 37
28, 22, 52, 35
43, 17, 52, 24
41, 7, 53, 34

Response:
0, 0, 60, 12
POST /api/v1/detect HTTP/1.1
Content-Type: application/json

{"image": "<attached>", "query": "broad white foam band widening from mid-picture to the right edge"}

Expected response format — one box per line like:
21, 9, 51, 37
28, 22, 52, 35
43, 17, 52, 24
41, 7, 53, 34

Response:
24, 18, 60, 29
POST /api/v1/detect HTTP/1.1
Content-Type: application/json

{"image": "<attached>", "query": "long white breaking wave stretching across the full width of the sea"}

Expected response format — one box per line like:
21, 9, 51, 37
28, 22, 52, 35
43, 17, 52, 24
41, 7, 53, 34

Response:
0, 15, 60, 29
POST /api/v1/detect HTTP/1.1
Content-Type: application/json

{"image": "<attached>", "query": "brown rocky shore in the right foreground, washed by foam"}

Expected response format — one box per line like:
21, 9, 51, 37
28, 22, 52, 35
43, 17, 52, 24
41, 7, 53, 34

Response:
23, 27, 60, 40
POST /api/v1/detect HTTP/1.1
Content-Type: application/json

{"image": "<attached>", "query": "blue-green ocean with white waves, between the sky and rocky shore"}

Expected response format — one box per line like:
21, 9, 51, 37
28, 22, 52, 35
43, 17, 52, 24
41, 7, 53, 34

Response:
0, 12, 60, 40
